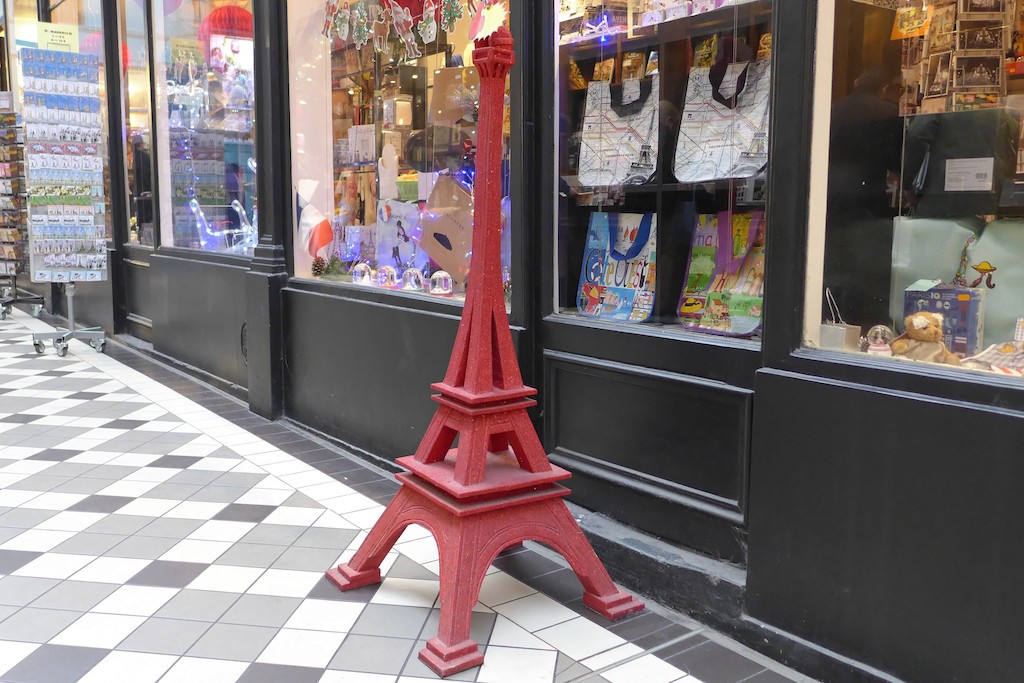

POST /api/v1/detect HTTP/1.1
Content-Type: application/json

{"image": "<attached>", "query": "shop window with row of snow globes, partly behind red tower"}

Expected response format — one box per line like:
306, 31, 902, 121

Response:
288, 0, 512, 301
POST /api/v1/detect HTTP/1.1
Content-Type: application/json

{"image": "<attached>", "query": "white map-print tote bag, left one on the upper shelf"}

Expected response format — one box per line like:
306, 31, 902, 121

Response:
580, 74, 660, 187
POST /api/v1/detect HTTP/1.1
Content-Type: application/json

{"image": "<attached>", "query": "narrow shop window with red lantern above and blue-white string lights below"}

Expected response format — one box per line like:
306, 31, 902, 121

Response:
152, 0, 258, 256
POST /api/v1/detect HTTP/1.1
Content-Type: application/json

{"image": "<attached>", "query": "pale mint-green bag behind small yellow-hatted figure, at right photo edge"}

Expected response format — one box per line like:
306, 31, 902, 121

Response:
953, 219, 1024, 345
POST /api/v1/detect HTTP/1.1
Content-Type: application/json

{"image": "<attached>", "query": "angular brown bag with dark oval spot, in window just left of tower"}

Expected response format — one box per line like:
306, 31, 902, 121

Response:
420, 175, 473, 285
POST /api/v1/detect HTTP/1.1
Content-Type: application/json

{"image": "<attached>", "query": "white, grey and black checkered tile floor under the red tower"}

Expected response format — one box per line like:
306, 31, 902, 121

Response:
0, 311, 804, 683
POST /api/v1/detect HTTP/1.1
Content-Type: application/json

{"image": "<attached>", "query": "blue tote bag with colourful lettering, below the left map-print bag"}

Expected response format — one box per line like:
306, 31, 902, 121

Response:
577, 213, 657, 323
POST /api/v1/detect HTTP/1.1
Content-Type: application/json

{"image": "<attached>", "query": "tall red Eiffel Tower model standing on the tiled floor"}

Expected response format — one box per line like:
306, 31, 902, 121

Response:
327, 22, 643, 676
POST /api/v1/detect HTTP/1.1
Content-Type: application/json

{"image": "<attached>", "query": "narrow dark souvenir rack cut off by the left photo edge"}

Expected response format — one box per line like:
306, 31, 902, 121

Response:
0, 108, 43, 321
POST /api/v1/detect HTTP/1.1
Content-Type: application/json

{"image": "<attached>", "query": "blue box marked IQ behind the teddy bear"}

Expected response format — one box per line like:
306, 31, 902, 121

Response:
903, 280, 985, 358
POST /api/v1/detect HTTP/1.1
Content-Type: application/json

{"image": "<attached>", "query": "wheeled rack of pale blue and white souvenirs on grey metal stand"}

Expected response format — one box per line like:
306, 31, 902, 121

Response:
20, 48, 108, 356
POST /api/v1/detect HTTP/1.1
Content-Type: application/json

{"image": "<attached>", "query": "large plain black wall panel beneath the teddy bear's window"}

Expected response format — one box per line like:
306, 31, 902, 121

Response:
748, 371, 1024, 683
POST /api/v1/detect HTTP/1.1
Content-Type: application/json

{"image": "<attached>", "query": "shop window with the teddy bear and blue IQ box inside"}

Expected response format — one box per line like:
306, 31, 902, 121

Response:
806, 0, 1024, 377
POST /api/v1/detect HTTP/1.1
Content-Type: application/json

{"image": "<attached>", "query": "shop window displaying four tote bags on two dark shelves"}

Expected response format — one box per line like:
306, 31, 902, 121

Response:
555, 0, 772, 339
